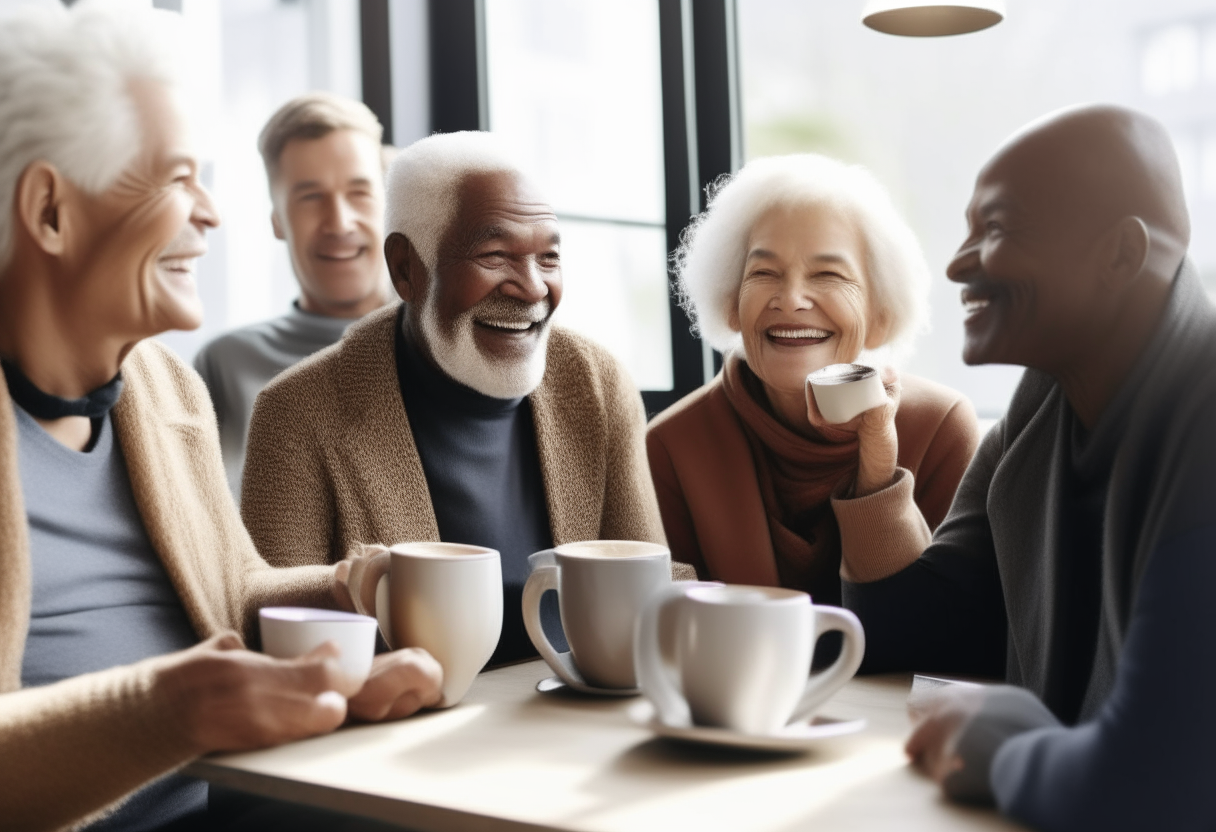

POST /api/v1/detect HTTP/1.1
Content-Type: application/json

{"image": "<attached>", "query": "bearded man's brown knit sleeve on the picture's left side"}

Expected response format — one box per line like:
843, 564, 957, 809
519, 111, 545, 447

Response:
241, 386, 336, 567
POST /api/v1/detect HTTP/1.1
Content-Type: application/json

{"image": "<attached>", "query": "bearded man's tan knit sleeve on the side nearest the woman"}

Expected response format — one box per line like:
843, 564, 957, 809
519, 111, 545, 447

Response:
599, 361, 666, 544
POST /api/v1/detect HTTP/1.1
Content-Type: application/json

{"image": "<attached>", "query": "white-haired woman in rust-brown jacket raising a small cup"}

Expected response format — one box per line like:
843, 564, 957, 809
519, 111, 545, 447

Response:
647, 154, 979, 603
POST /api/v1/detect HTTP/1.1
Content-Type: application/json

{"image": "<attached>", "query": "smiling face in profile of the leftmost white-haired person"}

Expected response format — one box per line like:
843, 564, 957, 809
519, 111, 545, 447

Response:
62, 75, 219, 339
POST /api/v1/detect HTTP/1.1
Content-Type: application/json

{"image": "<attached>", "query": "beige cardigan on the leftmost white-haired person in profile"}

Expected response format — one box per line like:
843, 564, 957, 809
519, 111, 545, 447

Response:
0, 342, 334, 830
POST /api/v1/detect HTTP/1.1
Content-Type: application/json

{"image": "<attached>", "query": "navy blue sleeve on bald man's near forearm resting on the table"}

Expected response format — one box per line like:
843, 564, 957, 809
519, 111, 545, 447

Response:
990, 524, 1216, 832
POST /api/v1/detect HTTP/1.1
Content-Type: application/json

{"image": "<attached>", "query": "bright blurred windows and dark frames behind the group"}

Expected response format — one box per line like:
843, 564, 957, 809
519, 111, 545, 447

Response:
0, 0, 1216, 418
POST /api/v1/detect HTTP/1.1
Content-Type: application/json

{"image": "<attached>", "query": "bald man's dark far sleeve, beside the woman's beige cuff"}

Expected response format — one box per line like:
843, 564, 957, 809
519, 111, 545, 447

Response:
841, 426, 1006, 676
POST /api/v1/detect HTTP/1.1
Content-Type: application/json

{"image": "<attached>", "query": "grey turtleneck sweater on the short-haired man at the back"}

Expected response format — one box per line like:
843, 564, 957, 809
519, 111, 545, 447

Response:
195, 300, 358, 500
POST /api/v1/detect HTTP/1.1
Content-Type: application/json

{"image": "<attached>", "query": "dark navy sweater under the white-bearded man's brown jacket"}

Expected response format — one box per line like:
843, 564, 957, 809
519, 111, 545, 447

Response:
395, 324, 564, 665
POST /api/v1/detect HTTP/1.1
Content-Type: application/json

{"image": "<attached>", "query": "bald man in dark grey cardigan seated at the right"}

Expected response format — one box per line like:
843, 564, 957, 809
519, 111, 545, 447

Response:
841, 107, 1216, 831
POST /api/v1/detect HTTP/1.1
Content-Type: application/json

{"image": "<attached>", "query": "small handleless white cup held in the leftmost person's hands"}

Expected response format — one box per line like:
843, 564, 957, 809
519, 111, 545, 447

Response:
258, 607, 376, 681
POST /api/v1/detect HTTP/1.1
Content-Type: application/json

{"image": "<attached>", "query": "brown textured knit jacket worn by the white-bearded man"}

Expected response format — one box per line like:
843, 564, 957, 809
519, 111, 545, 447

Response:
241, 305, 664, 566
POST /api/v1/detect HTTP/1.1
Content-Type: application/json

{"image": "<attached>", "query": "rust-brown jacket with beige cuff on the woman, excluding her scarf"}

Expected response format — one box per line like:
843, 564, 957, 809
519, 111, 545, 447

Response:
646, 375, 979, 586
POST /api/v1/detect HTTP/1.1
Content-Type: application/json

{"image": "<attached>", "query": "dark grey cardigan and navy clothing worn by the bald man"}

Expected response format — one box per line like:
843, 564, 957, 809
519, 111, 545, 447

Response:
844, 257, 1216, 830
